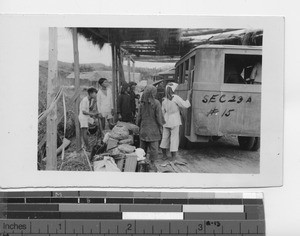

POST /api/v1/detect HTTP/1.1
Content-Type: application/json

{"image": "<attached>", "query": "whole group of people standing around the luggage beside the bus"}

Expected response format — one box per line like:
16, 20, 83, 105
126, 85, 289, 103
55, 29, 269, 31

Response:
78, 78, 191, 166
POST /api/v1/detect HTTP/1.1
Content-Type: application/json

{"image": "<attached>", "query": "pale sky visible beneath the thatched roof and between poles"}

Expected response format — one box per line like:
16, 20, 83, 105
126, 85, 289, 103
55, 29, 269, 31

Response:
39, 28, 174, 68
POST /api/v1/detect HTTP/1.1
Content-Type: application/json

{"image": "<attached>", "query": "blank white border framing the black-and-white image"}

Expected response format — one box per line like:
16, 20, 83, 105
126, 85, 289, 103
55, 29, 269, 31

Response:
0, 14, 285, 188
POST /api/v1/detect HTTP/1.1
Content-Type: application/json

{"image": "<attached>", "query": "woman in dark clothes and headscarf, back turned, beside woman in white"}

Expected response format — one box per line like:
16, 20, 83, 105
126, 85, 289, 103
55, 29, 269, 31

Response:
137, 85, 163, 164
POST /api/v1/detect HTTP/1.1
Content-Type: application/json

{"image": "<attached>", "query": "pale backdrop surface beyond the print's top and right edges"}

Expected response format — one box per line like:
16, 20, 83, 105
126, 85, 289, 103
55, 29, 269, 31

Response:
0, 0, 300, 236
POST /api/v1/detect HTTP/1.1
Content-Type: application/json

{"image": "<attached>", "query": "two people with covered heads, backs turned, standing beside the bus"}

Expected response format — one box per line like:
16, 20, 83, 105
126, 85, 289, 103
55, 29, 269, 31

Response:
137, 83, 191, 166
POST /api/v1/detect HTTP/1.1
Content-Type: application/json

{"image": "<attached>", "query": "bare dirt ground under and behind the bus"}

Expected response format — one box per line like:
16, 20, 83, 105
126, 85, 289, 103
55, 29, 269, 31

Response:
156, 137, 260, 174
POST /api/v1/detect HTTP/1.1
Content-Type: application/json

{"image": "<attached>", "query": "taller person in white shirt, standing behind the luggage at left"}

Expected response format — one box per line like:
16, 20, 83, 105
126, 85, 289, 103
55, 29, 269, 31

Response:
97, 78, 114, 129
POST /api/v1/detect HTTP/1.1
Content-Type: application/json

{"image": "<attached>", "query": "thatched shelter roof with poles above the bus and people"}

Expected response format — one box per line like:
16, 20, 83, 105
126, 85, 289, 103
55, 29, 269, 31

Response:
71, 28, 263, 62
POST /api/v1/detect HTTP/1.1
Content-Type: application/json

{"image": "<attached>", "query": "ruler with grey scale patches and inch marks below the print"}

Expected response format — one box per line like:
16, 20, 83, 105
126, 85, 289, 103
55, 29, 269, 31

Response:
0, 191, 265, 236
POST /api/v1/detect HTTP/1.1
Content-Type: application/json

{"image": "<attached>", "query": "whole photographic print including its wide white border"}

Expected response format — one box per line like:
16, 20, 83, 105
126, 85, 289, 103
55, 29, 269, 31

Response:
1, 15, 284, 188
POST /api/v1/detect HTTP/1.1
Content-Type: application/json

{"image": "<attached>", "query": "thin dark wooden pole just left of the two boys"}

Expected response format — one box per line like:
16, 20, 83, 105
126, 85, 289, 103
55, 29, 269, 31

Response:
72, 28, 81, 152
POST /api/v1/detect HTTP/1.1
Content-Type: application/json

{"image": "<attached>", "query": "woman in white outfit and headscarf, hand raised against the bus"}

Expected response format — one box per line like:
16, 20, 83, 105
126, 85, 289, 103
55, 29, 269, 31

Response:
160, 83, 191, 159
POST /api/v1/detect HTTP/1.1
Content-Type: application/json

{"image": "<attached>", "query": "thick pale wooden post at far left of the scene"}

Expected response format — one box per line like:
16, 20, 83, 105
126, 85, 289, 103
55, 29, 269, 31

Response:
46, 28, 58, 170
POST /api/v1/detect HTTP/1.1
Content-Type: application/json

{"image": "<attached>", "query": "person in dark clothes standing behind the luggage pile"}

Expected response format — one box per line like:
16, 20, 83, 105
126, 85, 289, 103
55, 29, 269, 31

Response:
118, 83, 133, 122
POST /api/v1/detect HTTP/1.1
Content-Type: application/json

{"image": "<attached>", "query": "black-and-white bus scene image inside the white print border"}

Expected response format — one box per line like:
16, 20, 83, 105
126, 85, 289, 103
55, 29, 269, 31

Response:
37, 27, 264, 174
